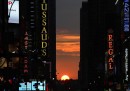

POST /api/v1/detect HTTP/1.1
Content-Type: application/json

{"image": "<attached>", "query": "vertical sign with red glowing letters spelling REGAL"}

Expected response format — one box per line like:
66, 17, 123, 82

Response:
107, 29, 114, 70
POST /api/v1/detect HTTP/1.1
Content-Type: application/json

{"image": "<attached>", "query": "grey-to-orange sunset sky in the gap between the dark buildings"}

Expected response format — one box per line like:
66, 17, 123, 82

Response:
56, 0, 83, 79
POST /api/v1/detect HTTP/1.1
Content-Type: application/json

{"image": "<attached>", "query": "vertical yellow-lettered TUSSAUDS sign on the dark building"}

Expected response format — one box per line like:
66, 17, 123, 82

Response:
41, 0, 48, 56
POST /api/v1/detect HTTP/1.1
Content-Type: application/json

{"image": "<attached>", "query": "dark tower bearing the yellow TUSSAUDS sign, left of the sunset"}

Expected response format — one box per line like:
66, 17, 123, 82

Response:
20, 0, 56, 82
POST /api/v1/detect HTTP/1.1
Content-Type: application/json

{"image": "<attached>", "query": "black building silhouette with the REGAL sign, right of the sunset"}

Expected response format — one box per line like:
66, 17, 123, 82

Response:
79, 0, 124, 91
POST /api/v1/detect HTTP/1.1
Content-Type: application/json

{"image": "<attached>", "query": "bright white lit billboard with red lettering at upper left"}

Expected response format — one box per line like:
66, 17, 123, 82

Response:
8, 0, 19, 24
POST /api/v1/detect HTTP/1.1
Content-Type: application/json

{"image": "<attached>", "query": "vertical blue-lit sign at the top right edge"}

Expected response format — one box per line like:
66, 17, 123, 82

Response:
124, 0, 129, 32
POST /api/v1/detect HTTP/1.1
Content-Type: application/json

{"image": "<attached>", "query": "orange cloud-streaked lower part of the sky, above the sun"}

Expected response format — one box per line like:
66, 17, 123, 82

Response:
56, 34, 80, 79
